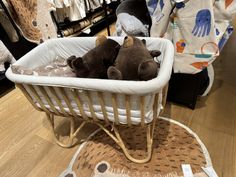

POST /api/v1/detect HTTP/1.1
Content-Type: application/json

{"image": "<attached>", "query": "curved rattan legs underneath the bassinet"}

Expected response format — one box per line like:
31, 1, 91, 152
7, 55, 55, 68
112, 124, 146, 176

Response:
46, 113, 156, 163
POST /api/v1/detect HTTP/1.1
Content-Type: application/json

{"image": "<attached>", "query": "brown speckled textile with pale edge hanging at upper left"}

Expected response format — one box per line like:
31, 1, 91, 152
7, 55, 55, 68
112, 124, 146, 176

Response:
5, 0, 57, 43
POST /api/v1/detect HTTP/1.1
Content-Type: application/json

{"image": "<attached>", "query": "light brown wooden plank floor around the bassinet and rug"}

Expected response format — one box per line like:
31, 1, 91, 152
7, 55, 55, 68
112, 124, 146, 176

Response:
0, 22, 236, 177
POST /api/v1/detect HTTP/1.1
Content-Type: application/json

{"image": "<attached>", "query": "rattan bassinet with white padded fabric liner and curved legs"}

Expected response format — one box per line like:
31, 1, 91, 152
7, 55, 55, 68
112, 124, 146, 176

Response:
6, 37, 174, 163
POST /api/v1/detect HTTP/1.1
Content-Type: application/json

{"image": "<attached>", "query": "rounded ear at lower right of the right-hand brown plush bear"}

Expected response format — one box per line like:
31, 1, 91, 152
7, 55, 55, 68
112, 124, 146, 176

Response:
138, 60, 159, 81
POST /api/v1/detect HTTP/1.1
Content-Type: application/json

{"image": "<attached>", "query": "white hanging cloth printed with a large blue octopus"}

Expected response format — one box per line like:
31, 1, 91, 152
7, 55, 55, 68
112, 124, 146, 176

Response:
172, 0, 219, 73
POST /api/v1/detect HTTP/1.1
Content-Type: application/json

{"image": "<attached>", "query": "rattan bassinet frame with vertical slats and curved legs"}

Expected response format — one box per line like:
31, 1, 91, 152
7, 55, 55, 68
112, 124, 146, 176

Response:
16, 84, 168, 163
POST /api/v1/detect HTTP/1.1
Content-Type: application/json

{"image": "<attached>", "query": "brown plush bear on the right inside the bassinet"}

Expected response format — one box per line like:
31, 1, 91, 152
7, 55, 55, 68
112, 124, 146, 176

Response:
107, 36, 161, 81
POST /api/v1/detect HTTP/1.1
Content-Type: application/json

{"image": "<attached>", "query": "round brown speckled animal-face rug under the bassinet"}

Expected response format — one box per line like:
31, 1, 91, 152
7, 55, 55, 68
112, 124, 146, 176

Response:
60, 117, 211, 177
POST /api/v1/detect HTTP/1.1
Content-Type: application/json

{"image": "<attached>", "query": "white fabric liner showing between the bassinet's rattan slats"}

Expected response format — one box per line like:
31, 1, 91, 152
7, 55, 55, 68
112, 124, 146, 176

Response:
34, 91, 163, 125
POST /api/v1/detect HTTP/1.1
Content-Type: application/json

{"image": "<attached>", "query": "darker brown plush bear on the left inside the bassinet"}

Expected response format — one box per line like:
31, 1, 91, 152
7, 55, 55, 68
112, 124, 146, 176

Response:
67, 35, 120, 79
